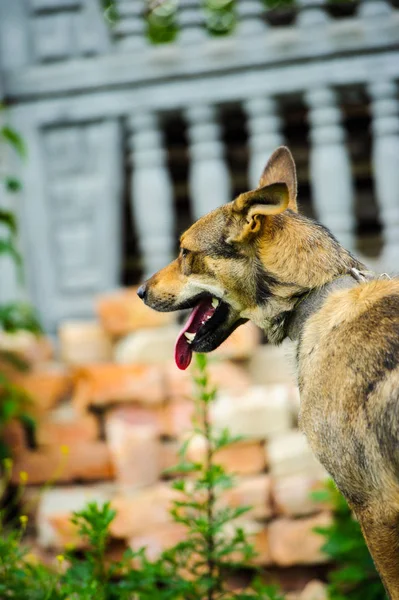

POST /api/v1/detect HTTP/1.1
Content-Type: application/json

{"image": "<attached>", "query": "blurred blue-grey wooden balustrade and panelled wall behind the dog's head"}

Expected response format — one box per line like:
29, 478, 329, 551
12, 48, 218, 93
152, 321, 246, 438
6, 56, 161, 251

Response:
0, 0, 399, 332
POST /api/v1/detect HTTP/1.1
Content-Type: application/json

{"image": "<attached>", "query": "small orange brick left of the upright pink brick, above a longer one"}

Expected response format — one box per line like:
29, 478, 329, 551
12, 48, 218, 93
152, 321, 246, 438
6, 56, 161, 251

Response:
36, 404, 99, 447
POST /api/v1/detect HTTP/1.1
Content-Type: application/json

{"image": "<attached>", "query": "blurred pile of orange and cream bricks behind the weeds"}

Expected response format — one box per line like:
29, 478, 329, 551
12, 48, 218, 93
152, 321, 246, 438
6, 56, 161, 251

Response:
0, 289, 331, 600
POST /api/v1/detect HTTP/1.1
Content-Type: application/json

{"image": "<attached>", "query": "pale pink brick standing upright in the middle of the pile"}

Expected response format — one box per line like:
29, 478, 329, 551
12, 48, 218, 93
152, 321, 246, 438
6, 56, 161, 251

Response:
105, 407, 162, 487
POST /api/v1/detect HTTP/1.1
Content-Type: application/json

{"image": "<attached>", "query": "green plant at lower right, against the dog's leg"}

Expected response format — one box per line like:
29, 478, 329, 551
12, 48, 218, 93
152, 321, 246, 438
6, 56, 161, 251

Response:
313, 481, 386, 600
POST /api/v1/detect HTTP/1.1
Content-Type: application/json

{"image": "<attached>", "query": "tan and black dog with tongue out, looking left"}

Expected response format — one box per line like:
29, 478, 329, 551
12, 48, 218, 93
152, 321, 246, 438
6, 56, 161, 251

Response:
138, 147, 399, 600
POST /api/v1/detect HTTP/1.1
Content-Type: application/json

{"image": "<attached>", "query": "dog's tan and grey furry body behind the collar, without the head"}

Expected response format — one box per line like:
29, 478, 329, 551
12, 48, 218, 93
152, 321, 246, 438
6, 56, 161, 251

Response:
298, 279, 399, 597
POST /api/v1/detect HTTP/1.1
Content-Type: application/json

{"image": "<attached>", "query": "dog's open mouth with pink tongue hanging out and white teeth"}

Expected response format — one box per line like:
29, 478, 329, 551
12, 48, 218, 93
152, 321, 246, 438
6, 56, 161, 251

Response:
175, 296, 246, 370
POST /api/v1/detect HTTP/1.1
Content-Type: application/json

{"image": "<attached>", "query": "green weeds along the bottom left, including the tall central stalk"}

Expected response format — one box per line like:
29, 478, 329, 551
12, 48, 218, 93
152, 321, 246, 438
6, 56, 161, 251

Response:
0, 355, 283, 600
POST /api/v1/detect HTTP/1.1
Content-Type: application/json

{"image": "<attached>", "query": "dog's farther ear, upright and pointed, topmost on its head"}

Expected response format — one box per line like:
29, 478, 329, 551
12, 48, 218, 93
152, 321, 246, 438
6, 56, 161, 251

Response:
259, 146, 298, 212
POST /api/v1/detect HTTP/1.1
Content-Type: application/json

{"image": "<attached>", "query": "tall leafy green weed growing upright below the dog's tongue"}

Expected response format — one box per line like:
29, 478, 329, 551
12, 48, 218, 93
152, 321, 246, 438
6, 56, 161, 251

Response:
163, 354, 284, 600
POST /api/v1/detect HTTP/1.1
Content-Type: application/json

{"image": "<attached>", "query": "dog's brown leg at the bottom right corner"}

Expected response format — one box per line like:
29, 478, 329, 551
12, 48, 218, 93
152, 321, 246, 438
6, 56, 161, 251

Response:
355, 507, 399, 600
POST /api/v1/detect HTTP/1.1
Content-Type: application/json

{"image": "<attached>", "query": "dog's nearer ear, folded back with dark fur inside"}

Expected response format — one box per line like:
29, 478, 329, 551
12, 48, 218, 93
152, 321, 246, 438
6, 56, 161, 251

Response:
228, 183, 290, 242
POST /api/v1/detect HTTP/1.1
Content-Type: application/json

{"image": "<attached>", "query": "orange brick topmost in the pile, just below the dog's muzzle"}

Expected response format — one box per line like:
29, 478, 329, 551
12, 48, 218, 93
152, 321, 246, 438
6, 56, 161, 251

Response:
96, 288, 175, 337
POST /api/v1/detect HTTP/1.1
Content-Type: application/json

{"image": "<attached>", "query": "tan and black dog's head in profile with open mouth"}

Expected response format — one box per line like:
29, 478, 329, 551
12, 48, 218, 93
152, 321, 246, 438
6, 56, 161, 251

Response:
138, 147, 354, 368
